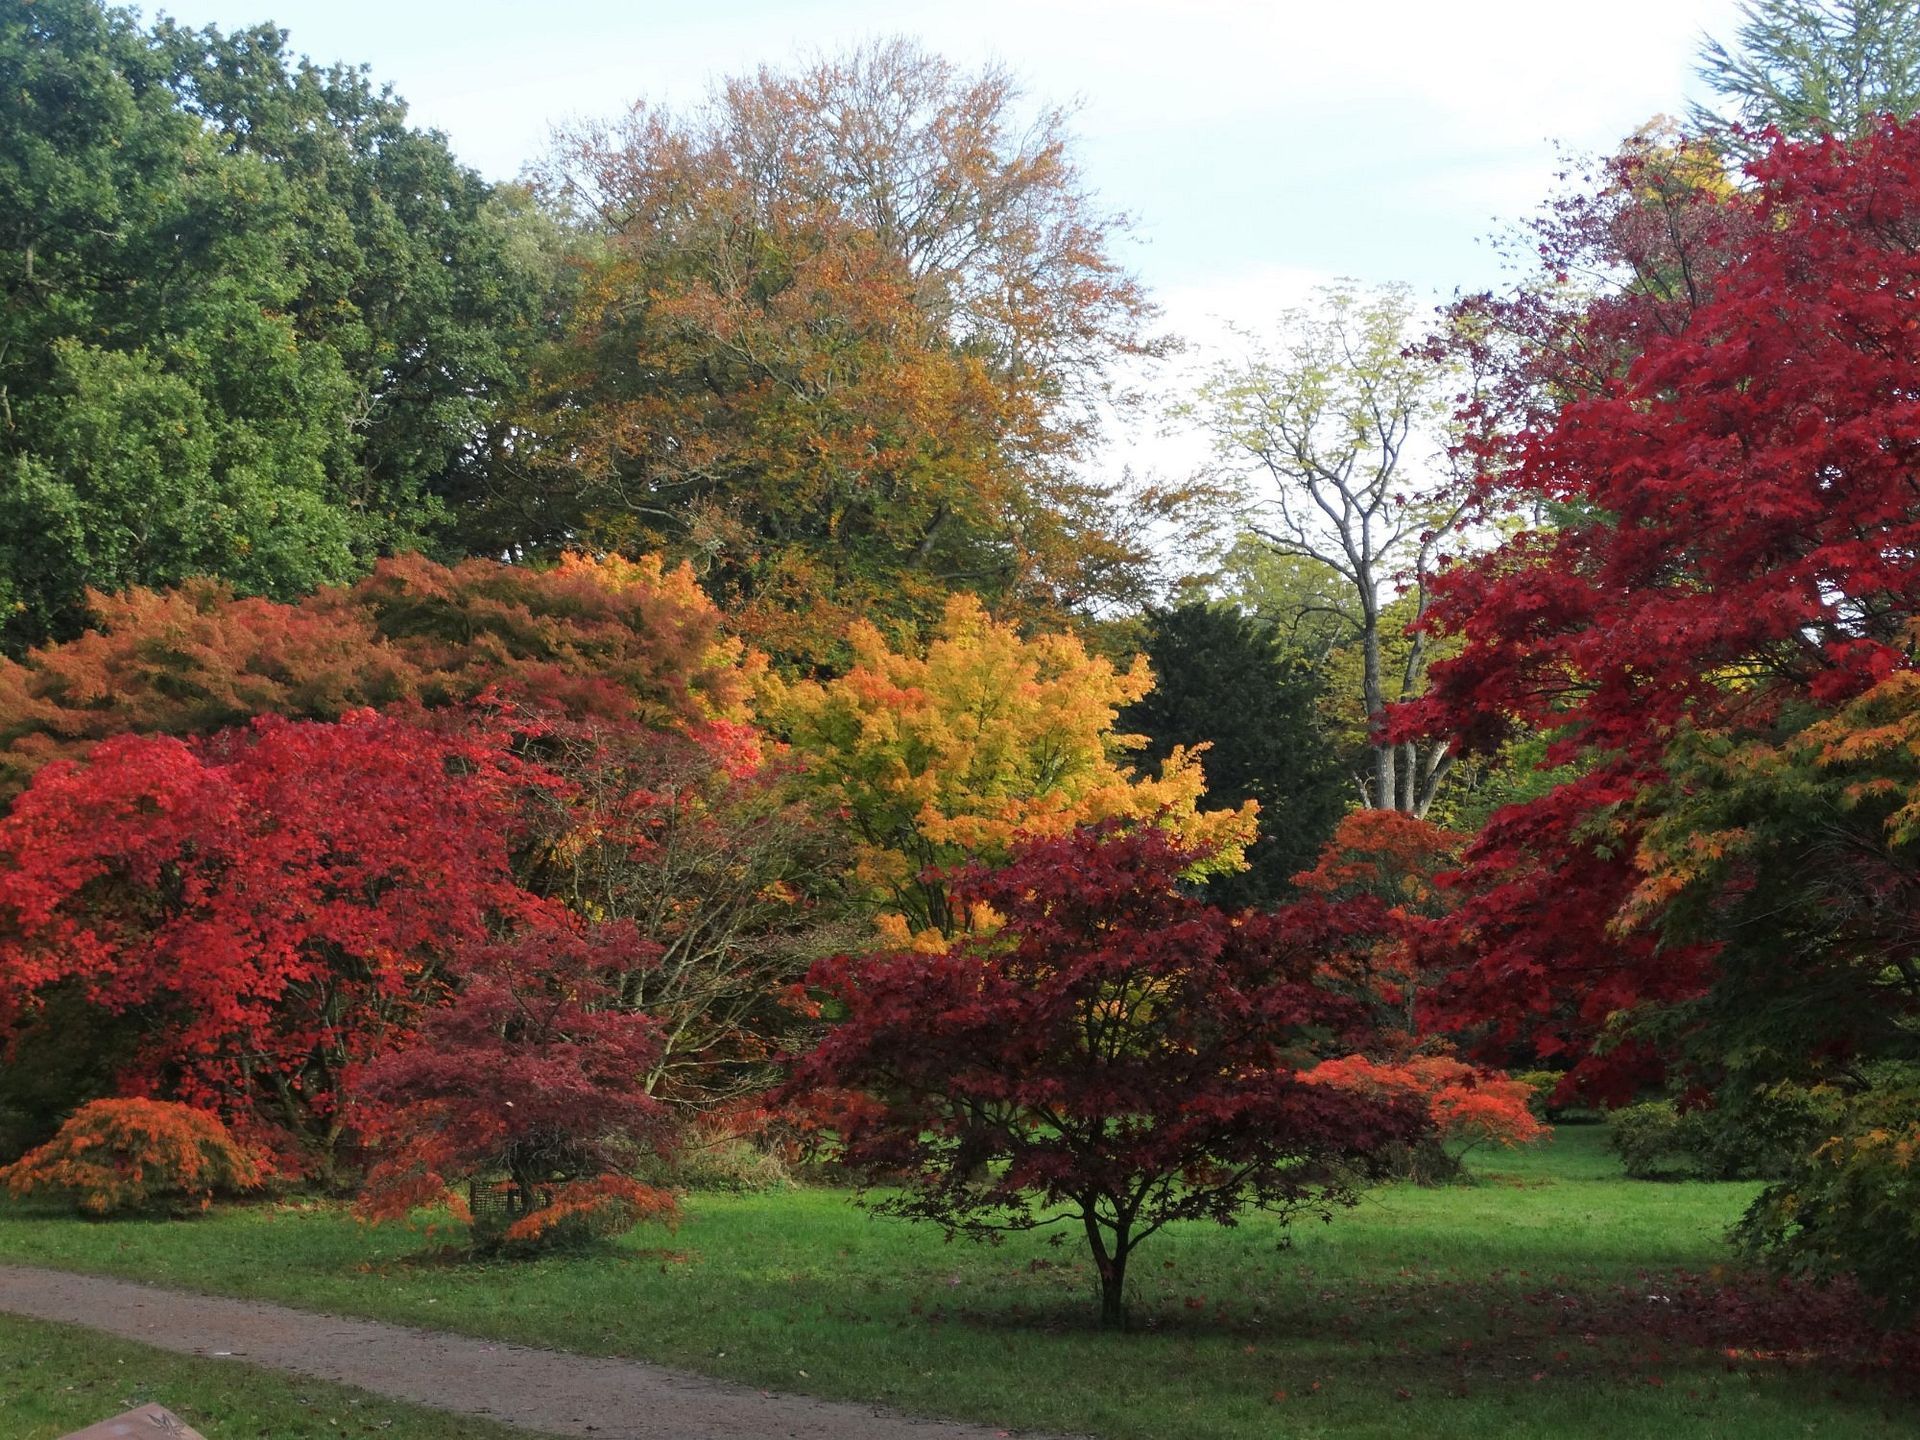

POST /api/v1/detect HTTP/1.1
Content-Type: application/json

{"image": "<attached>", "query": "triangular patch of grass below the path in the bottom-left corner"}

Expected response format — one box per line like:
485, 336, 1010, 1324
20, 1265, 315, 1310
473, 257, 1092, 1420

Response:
0, 1315, 549, 1440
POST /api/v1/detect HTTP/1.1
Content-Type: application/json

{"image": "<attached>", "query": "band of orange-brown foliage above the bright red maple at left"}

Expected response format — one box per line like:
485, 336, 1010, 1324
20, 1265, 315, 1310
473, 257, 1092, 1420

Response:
0, 555, 758, 799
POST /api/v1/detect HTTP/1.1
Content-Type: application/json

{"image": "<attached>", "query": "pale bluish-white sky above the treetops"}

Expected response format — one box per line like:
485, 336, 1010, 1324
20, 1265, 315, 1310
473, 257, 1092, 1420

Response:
148, 0, 1738, 495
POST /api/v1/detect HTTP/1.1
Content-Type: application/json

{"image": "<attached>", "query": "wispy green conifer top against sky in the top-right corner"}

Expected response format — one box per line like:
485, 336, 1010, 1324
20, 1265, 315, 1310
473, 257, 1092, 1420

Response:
1692, 0, 1920, 154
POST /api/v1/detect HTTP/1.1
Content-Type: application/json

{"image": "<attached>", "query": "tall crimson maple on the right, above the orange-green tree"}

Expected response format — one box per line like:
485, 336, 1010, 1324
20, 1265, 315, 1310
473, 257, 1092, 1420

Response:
1394, 121, 1920, 1091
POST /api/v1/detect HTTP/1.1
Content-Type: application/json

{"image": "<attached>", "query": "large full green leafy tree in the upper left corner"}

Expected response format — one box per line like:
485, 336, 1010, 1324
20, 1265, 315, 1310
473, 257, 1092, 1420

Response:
0, 0, 545, 649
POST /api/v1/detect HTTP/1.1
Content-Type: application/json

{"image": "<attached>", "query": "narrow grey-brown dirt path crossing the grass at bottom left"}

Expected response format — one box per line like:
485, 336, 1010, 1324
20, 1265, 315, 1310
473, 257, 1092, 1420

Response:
0, 1265, 1067, 1440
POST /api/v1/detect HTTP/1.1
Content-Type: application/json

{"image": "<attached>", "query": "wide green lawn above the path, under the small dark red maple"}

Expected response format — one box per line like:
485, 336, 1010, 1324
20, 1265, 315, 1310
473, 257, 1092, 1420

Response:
0, 1127, 1920, 1440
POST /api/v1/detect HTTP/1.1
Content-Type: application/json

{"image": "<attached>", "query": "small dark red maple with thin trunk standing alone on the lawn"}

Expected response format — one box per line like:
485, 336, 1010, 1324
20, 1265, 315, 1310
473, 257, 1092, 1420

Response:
795, 828, 1425, 1325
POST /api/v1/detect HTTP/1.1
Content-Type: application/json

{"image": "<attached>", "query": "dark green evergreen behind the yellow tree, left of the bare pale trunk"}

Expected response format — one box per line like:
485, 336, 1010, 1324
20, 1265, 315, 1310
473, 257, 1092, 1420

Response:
1117, 603, 1350, 910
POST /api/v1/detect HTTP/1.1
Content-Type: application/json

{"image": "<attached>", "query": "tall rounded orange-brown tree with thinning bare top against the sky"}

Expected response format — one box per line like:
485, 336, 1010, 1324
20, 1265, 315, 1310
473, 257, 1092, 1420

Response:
528, 40, 1158, 668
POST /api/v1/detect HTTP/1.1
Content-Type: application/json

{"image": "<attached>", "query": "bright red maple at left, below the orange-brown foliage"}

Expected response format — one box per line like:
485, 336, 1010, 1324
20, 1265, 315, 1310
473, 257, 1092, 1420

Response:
0, 712, 543, 1165
